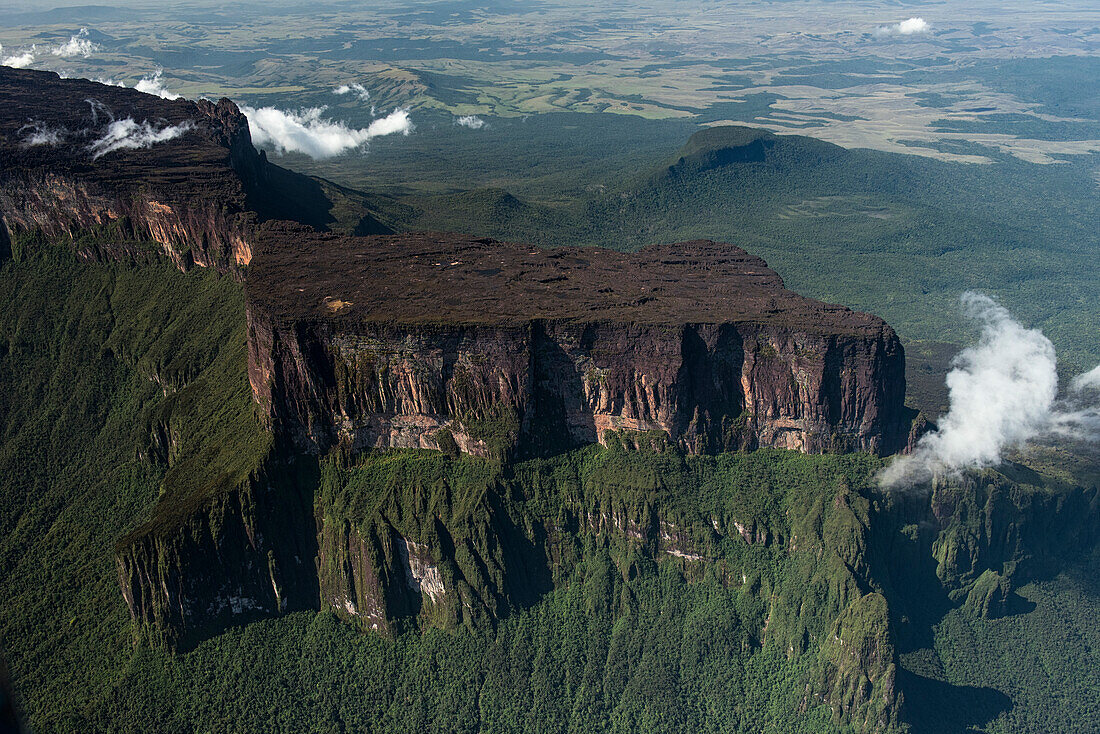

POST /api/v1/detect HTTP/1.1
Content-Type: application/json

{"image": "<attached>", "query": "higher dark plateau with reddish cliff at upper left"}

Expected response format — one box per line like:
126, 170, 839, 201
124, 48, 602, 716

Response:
0, 68, 264, 273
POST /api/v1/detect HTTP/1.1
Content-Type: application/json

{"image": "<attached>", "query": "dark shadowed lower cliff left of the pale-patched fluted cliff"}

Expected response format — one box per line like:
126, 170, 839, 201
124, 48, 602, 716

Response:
116, 460, 318, 648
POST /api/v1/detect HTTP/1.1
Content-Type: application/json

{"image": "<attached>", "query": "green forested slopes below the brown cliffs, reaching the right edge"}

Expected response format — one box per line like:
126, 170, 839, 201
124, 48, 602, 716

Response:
0, 229, 1100, 733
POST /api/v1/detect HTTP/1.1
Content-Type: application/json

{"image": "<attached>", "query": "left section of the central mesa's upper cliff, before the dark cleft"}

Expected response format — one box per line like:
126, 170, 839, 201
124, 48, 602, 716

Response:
249, 319, 531, 456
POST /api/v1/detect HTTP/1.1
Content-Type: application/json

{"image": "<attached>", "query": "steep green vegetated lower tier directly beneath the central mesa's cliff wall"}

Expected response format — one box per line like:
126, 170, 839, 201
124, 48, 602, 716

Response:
308, 442, 898, 731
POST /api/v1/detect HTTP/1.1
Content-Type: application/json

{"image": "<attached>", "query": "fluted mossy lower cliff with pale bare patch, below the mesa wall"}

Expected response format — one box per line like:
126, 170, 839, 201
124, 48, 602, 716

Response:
317, 479, 550, 634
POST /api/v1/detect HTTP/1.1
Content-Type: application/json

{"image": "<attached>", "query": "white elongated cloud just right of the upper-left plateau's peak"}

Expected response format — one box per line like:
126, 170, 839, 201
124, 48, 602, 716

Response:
241, 106, 413, 158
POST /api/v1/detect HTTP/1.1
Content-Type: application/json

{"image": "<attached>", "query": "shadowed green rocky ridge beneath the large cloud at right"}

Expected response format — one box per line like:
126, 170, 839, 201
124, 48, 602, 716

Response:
869, 463, 1100, 624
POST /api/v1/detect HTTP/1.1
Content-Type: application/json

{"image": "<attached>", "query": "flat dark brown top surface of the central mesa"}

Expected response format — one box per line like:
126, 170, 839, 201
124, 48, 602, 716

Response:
248, 224, 893, 338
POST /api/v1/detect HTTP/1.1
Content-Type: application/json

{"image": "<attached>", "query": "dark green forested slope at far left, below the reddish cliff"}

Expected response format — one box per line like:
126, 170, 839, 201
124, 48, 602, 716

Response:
0, 242, 266, 731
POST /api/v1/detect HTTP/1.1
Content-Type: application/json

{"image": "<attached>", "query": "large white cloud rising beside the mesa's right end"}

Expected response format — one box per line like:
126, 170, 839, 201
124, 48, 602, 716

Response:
879, 293, 1100, 487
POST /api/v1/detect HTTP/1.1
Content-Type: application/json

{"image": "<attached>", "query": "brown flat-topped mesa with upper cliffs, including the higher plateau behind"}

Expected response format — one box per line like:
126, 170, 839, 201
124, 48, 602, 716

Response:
0, 68, 910, 454
